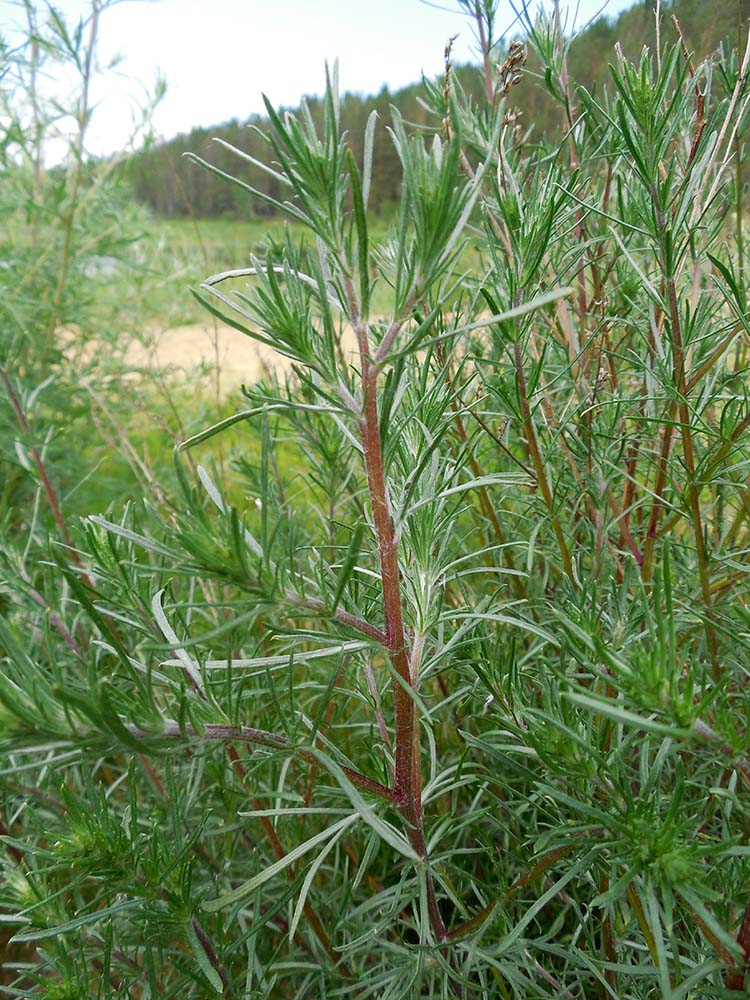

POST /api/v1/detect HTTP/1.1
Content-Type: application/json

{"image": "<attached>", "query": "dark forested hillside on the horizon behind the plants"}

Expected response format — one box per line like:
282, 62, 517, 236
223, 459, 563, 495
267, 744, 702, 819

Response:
126, 0, 750, 218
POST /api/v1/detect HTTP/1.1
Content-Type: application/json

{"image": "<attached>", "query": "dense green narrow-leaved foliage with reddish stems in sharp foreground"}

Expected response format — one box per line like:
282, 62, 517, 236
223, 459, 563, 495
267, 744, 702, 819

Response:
0, 2, 750, 1000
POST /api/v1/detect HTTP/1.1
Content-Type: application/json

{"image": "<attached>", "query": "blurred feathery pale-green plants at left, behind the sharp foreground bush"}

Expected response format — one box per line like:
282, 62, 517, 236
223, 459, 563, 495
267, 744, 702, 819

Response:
0, 0, 222, 540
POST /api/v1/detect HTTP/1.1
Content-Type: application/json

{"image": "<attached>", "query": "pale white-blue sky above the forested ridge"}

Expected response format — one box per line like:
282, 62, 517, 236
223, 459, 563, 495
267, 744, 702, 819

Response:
0, 0, 633, 154
